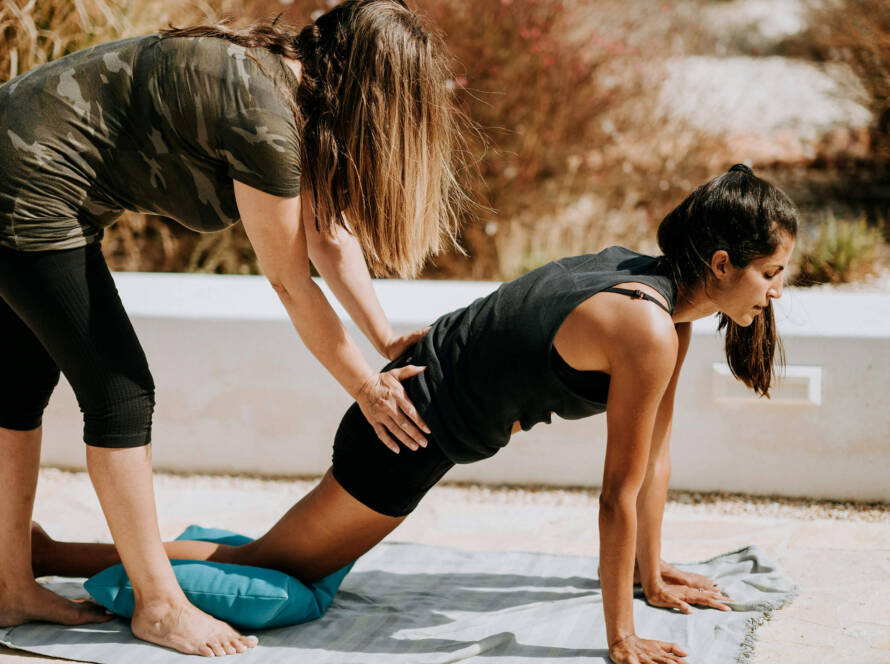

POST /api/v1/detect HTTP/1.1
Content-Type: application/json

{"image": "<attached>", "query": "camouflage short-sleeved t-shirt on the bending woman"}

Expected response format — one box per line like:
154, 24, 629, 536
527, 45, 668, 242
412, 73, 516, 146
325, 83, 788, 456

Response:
0, 35, 300, 251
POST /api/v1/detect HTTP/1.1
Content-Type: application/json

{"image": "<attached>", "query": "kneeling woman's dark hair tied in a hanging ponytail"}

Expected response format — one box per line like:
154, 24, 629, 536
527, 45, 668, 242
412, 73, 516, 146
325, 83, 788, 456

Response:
658, 164, 798, 397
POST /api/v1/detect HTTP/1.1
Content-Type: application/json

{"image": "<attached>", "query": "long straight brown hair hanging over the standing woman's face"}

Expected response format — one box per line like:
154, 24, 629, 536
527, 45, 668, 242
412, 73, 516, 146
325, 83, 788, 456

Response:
161, 0, 469, 277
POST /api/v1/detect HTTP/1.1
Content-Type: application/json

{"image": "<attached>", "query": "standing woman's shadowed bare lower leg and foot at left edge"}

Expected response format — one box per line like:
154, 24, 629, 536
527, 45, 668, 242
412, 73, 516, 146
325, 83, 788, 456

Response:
0, 427, 110, 627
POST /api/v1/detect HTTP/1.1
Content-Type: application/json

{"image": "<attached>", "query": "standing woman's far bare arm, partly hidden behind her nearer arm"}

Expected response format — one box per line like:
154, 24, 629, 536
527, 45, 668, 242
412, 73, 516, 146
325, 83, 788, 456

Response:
303, 208, 428, 360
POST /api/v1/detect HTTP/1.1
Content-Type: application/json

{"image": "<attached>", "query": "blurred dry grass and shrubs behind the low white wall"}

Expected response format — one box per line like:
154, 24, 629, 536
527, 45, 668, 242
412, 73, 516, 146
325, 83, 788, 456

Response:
0, 0, 890, 285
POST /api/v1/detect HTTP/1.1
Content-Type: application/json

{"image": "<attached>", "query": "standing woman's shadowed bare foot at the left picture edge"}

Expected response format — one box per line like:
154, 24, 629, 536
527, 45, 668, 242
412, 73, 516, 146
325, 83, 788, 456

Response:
0, 581, 112, 627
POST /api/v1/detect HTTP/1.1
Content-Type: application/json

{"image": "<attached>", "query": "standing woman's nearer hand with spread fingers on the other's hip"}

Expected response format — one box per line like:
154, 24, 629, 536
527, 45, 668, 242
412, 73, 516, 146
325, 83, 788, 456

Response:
355, 364, 430, 454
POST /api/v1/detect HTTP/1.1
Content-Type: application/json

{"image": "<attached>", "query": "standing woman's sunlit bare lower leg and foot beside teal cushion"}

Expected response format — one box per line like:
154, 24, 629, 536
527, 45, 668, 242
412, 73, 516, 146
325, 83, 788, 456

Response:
86, 445, 256, 656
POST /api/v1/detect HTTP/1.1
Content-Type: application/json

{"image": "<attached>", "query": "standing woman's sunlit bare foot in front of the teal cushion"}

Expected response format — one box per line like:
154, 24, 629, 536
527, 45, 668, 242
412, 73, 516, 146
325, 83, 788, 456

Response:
131, 601, 258, 657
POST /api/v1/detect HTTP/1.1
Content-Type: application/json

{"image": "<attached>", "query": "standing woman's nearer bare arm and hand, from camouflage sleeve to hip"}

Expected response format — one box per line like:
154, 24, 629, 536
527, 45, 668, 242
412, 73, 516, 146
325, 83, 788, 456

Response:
234, 181, 426, 453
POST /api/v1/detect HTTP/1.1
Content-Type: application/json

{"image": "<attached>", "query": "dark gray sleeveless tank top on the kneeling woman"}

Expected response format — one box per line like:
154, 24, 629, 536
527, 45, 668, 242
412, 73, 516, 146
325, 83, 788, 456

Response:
389, 247, 676, 463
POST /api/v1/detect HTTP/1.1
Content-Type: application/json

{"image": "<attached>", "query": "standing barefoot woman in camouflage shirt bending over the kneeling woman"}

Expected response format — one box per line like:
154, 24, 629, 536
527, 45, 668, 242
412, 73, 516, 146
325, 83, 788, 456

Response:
0, 0, 465, 655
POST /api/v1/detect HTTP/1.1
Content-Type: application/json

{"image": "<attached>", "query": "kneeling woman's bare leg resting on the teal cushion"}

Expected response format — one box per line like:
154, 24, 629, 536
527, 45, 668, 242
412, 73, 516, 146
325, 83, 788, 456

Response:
33, 470, 405, 583
